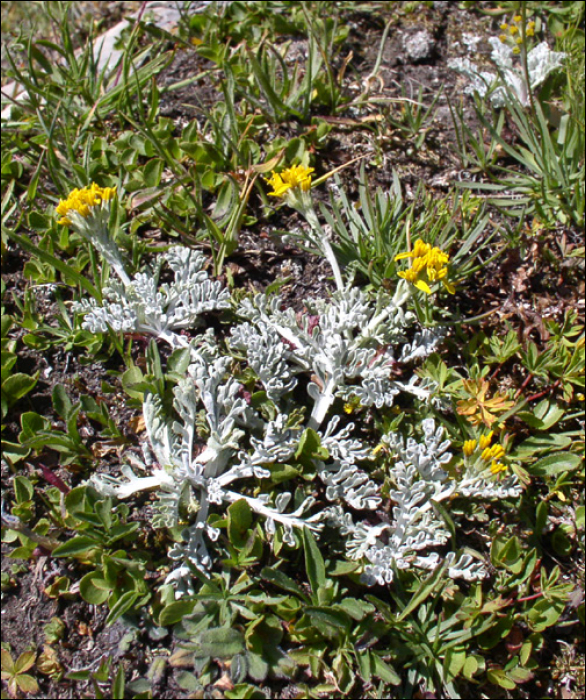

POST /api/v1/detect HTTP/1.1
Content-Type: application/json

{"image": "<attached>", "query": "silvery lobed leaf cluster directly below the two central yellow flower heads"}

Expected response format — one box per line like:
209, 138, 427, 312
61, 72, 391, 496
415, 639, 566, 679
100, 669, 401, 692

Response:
231, 282, 440, 429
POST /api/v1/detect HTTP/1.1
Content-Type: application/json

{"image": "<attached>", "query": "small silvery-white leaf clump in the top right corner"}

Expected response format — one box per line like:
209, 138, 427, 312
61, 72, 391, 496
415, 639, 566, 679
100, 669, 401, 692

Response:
448, 37, 566, 107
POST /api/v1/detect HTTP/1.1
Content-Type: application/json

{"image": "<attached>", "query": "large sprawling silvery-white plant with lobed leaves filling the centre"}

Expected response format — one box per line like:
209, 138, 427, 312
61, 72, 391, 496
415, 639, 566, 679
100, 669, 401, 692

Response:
57, 180, 518, 595
